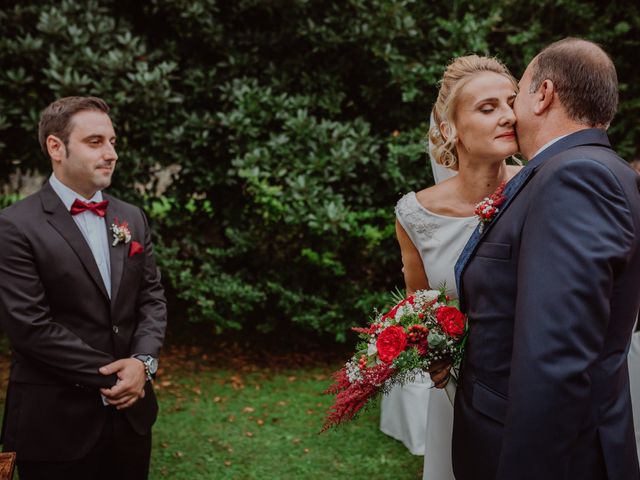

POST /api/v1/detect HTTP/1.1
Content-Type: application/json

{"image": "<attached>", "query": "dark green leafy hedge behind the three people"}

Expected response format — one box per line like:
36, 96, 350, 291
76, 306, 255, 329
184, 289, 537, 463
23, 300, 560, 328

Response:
0, 0, 640, 339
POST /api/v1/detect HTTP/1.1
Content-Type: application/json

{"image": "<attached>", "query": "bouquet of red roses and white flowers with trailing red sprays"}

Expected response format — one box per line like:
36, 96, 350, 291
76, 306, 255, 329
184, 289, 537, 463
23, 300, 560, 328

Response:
322, 290, 467, 431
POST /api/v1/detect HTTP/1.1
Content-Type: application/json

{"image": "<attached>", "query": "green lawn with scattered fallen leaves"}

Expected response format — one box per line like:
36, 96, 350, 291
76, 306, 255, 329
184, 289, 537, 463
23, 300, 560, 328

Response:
0, 336, 422, 480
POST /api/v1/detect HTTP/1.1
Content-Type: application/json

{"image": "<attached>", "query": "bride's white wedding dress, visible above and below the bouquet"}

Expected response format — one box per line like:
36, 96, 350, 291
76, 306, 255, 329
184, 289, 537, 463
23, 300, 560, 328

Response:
380, 192, 478, 480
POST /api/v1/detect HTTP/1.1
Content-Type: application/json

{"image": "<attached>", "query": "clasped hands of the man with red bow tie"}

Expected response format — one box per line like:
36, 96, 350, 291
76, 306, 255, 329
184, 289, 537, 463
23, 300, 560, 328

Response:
100, 358, 147, 410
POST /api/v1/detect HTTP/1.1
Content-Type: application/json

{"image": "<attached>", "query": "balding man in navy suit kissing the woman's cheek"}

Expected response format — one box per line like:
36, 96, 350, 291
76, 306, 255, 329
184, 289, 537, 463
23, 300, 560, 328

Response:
453, 39, 640, 480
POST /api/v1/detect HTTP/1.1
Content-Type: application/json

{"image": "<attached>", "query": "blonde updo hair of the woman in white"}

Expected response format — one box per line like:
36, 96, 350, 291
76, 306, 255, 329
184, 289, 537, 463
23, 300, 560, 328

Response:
429, 55, 518, 170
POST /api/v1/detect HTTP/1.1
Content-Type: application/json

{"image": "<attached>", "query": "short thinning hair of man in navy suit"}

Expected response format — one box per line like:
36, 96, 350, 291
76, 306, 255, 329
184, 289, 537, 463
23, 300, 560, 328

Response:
530, 37, 618, 127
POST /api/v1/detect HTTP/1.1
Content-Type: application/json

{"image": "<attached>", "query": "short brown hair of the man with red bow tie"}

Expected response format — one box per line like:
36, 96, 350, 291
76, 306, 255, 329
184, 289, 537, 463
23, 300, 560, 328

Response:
38, 97, 109, 157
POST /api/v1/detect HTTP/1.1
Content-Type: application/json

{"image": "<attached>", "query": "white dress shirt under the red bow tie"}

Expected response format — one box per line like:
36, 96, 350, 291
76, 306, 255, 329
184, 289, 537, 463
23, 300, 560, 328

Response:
49, 173, 111, 298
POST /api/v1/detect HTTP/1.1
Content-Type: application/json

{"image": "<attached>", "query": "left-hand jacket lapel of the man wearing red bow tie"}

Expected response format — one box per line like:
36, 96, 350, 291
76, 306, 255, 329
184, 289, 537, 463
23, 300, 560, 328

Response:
40, 182, 109, 300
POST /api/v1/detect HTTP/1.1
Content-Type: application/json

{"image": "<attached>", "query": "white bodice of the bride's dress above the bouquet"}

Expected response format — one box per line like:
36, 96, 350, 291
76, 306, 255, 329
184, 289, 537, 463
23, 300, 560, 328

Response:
396, 192, 478, 297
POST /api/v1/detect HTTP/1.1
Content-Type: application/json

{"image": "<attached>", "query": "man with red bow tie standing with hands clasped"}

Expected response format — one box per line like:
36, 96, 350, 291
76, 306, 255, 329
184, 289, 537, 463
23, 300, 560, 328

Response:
0, 97, 166, 480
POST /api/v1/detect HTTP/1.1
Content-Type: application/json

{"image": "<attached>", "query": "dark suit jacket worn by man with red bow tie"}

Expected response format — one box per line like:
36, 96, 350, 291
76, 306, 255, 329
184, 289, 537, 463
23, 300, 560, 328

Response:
0, 182, 167, 461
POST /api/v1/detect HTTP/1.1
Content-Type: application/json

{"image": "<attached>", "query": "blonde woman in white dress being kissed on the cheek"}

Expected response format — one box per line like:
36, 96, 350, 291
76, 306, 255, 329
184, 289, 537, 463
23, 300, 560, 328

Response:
380, 55, 519, 480
